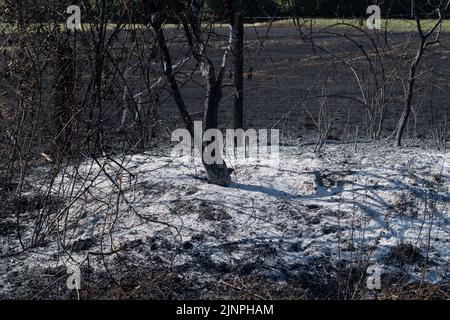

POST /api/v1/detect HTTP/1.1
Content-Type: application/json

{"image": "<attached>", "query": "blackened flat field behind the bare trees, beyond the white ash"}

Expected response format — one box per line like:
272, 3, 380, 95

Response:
0, 25, 450, 154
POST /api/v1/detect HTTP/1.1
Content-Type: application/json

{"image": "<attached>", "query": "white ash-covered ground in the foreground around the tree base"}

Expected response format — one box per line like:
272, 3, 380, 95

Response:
0, 143, 450, 299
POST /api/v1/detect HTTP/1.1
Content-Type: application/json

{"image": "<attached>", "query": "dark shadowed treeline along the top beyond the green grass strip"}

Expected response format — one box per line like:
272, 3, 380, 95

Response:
0, 0, 448, 22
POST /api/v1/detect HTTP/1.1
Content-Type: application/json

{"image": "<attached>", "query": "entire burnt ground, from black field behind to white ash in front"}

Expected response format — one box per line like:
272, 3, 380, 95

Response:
0, 24, 450, 300
